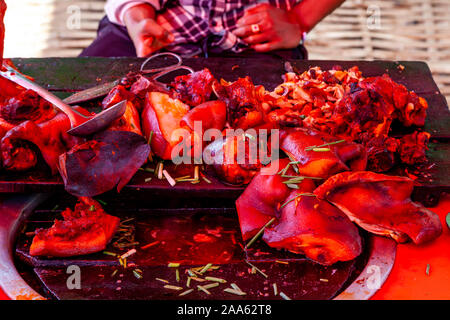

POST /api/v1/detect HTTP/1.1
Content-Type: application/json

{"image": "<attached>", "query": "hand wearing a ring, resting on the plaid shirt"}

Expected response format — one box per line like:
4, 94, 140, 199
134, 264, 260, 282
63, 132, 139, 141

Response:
233, 3, 302, 52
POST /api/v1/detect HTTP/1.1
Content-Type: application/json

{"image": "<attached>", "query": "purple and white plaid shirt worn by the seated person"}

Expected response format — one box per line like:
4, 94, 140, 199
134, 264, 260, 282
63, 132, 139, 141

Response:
105, 0, 300, 56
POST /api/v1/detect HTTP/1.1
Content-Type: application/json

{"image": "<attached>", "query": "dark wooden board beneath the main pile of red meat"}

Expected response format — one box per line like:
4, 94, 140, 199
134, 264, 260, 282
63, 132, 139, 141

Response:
0, 56, 450, 206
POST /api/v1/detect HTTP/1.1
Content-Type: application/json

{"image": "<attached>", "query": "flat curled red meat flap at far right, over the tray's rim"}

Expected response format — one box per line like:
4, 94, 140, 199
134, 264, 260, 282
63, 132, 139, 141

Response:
314, 171, 442, 244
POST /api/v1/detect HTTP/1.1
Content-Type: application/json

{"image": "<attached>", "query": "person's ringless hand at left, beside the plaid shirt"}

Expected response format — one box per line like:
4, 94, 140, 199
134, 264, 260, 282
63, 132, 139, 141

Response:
124, 4, 174, 57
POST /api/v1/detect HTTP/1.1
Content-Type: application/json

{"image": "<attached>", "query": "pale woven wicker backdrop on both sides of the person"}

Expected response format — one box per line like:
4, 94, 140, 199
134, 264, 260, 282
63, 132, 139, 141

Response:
5, 0, 450, 104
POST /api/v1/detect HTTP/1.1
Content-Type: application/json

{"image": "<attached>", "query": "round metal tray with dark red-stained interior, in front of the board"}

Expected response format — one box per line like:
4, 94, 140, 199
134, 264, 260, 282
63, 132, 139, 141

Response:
0, 194, 396, 300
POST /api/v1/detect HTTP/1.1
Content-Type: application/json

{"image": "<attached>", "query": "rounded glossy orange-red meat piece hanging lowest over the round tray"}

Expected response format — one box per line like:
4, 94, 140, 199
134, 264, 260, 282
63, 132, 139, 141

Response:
263, 191, 362, 265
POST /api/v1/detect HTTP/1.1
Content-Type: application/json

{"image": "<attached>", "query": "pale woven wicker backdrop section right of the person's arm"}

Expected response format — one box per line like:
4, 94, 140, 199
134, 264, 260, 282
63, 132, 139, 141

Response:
307, 0, 450, 104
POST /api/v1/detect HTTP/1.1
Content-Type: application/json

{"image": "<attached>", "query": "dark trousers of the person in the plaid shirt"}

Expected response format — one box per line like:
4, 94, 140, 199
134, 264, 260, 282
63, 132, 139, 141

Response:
80, 17, 308, 59
